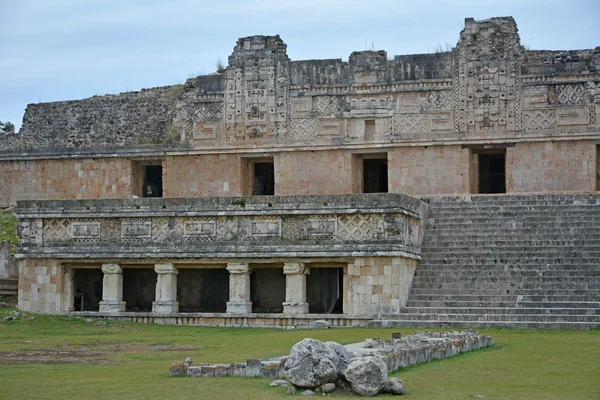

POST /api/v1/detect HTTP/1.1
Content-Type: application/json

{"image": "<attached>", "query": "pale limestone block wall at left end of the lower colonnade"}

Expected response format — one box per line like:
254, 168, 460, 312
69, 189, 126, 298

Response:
18, 259, 71, 312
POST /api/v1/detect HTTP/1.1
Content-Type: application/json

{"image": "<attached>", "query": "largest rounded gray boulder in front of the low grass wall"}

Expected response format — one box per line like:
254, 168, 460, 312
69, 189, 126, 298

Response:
285, 339, 338, 388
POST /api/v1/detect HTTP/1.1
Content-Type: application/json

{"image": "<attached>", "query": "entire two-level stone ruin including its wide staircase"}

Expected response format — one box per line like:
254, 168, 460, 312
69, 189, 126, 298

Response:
0, 17, 600, 328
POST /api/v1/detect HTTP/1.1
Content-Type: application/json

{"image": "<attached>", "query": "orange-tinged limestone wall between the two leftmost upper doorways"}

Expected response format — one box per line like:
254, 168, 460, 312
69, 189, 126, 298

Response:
163, 154, 245, 197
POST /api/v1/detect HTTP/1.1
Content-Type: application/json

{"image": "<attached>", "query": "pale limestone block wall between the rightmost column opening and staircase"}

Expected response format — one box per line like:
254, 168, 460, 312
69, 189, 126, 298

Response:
344, 257, 417, 316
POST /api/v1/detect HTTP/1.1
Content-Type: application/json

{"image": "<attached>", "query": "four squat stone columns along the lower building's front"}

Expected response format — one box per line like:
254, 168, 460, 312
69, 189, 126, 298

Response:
100, 262, 308, 314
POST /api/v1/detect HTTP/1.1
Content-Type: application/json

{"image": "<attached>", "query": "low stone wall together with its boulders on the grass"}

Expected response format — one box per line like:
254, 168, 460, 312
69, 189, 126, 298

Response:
170, 330, 494, 396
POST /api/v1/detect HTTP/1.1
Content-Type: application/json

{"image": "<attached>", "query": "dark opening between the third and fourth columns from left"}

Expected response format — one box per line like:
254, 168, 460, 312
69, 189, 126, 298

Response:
250, 268, 285, 313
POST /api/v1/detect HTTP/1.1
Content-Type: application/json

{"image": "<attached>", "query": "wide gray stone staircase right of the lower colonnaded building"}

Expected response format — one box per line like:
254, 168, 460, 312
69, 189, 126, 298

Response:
371, 194, 600, 329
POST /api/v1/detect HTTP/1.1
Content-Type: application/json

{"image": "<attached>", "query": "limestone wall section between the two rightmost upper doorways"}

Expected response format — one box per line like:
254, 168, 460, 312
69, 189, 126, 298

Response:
388, 146, 469, 196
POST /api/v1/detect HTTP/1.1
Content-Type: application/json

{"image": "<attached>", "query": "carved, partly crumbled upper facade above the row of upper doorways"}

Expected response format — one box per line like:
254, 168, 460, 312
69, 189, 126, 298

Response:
0, 17, 600, 156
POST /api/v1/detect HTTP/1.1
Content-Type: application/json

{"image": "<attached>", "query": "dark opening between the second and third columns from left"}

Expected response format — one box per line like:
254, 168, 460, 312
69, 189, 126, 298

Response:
177, 268, 229, 313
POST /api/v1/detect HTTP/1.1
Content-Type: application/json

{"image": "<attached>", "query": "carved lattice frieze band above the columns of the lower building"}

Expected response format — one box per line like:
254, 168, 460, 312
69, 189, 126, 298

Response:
32, 213, 418, 245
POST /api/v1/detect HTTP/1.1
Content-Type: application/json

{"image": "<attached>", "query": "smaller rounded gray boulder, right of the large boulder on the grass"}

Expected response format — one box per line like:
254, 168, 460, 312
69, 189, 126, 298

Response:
345, 356, 387, 396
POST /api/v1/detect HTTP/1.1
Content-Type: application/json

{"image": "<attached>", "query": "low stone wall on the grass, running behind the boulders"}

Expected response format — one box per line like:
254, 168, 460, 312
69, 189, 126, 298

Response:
170, 330, 494, 379
